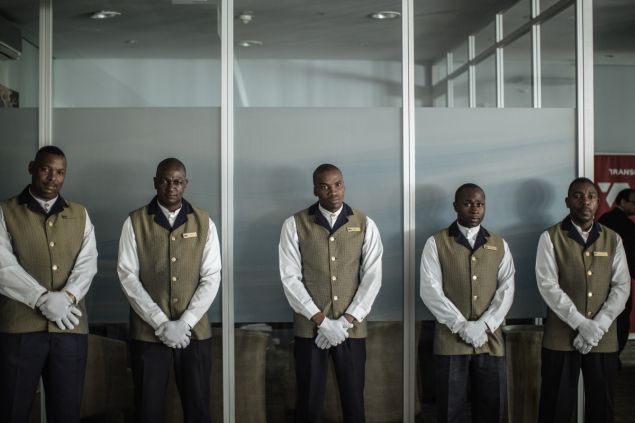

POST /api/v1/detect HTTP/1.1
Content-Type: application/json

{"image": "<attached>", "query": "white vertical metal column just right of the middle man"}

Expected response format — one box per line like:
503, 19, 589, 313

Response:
401, 0, 417, 423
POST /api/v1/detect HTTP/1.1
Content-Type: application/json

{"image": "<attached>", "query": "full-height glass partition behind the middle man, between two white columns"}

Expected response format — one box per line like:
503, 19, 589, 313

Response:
234, 0, 403, 422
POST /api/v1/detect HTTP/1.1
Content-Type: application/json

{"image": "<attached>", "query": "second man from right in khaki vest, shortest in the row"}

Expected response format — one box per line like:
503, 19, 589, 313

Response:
420, 183, 515, 423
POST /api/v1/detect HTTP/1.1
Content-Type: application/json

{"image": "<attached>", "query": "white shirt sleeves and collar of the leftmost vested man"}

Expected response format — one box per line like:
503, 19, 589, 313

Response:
0, 194, 97, 308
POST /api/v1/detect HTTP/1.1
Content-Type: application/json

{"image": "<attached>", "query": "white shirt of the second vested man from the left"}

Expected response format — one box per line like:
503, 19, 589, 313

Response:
117, 204, 221, 330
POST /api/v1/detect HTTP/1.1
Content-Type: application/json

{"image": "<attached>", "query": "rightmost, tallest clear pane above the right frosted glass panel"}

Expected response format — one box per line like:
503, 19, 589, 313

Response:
540, 6, 576, 107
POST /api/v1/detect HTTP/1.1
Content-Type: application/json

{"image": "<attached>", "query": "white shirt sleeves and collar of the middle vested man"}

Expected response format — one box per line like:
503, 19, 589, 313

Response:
278, 206, 384, 322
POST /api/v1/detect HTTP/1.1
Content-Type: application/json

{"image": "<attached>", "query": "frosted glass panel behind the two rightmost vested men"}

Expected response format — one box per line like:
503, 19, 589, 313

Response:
416, 109, 576, 319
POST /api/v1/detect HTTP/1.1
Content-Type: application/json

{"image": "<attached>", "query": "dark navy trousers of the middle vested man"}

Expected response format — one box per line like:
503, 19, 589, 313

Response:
295, 337, 366, 423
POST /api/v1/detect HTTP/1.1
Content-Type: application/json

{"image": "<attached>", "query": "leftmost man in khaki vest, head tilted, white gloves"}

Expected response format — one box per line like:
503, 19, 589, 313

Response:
0, 146, 97, 423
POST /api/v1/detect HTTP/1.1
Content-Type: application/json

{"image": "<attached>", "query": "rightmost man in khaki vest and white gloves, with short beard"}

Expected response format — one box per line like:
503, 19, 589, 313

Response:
536, 178, 630, 423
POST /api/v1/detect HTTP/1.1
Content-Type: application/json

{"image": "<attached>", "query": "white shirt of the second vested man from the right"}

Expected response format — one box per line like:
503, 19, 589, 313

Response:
419, 223, 516, 333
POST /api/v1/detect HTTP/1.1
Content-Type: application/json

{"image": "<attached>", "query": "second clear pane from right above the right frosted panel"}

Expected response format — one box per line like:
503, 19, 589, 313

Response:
504, 33, 533, 107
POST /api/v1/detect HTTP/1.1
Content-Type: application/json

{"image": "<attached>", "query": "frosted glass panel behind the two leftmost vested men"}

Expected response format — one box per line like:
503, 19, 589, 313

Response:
53, 108, 221, 323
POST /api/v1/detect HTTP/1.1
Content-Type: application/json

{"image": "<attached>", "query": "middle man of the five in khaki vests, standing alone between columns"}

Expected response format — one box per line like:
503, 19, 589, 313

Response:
279, 164, 383, 423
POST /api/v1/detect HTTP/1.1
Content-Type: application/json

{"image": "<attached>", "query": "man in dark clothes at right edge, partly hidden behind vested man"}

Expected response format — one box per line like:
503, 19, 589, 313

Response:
599, 188, 635, 362
